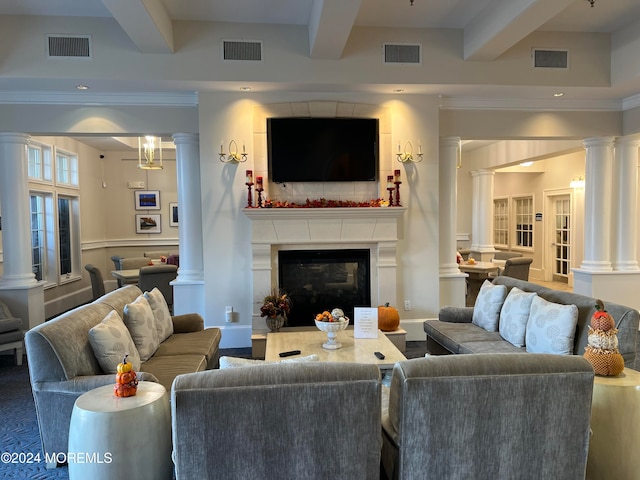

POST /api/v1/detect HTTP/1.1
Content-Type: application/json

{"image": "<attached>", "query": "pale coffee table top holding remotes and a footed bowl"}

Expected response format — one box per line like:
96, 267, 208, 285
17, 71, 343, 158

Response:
265, 328, 407, 369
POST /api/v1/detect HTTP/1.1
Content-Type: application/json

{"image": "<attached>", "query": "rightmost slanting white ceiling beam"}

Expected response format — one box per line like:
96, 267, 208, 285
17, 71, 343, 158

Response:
464, 0, 576, 60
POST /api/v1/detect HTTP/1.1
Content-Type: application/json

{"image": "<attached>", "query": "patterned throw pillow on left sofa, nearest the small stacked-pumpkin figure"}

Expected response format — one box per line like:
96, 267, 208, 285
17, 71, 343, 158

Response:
89, 310, 140, 373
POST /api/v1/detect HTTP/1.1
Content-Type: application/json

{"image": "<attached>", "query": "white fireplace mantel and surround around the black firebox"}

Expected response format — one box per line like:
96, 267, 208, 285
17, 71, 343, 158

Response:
243, 207, 406, 332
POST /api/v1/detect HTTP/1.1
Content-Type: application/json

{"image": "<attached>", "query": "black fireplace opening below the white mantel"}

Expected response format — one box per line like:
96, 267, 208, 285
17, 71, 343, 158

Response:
278, 249, 371, 327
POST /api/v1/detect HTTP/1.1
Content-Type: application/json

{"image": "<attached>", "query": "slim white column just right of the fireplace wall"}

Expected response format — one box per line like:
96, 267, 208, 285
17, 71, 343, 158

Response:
439, 137, 461, 275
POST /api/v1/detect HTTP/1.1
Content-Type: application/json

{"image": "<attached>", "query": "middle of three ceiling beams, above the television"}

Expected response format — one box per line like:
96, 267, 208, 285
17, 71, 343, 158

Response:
308, 0, 362, 59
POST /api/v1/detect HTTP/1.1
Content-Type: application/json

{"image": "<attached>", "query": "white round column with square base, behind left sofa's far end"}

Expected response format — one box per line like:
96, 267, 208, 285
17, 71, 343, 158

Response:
172, 133, 205, 316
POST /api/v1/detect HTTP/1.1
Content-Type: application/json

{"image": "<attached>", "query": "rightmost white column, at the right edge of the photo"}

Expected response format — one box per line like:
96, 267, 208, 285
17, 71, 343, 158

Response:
611, 136, 640, 270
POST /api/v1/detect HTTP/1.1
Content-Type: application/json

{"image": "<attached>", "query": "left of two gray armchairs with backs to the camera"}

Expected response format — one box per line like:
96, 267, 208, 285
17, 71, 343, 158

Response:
171, 362, 381, 480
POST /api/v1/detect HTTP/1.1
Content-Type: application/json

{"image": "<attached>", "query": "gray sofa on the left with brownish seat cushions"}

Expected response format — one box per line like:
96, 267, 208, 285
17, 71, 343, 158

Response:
25, 285, 221, 464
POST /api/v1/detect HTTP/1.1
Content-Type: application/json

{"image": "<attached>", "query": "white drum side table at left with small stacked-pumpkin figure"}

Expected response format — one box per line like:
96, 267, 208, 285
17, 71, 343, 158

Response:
67, 375, 173, 480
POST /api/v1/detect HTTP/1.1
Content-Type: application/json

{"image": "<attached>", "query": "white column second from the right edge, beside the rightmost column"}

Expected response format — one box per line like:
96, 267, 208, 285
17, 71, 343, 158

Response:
580, 137, 616, 272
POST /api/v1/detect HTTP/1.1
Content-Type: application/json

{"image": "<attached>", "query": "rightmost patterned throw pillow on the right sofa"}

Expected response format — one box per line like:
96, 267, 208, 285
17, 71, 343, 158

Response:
525, 296, 578, 355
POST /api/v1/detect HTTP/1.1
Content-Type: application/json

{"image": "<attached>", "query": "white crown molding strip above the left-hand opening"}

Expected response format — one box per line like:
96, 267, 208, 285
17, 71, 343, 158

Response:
0, 91, 198, 107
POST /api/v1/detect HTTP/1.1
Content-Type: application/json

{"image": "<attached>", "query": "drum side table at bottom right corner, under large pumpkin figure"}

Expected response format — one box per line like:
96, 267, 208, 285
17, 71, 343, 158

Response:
587, 368, 640, 480
